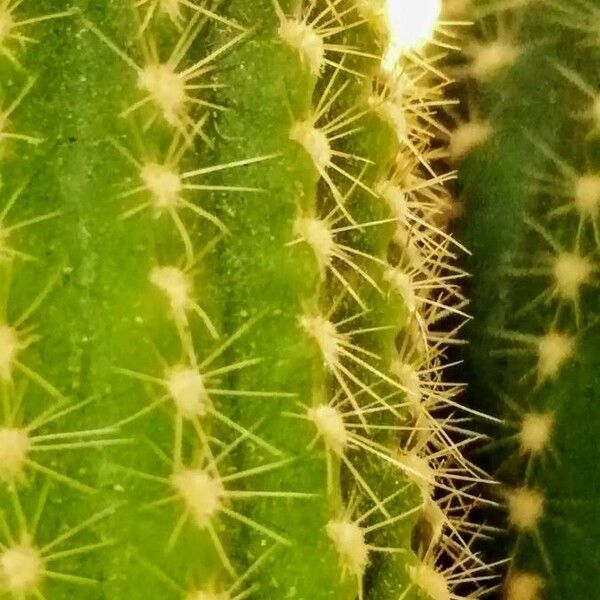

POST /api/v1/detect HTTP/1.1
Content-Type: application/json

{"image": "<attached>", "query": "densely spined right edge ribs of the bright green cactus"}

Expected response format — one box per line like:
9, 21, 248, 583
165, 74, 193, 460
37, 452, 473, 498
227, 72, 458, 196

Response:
268, 2, 493, 599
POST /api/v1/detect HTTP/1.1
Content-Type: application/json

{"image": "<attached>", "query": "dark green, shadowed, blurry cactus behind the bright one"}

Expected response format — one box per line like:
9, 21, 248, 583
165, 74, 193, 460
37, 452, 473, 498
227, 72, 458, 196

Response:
456, 0, 600, 600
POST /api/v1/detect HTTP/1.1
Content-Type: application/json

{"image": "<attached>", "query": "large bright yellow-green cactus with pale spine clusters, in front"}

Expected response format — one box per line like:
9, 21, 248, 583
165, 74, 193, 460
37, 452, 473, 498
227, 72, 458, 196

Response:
0, 0, 489, 600
